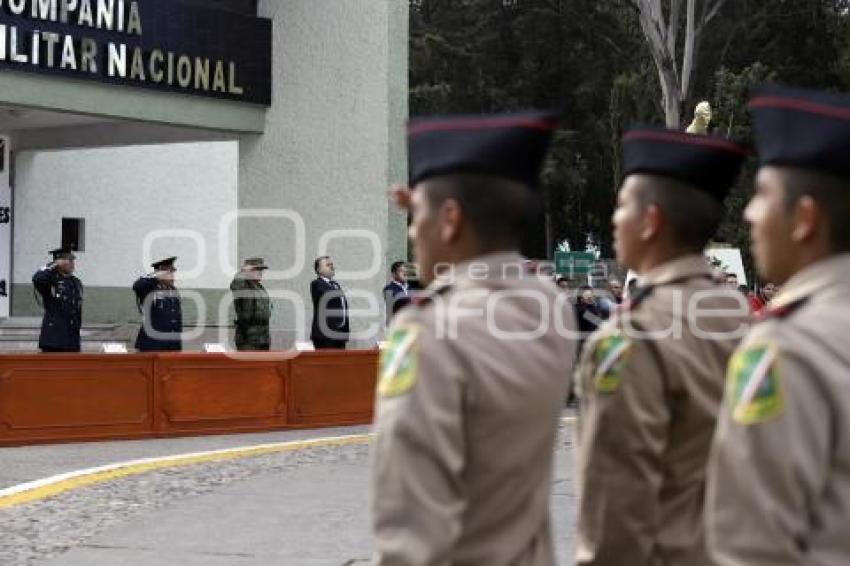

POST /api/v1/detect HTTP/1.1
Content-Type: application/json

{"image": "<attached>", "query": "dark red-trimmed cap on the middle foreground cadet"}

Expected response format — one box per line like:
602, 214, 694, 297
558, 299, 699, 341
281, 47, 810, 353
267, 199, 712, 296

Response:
623, 128, 749, 201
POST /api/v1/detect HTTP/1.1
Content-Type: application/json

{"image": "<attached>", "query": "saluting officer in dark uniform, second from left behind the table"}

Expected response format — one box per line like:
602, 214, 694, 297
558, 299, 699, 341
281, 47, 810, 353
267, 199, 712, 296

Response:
133, 257, 183, 352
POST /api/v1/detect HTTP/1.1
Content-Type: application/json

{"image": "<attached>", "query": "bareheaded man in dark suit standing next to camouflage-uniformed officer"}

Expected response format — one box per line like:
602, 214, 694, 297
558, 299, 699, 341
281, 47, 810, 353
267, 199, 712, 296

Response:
310, 256, 349, 350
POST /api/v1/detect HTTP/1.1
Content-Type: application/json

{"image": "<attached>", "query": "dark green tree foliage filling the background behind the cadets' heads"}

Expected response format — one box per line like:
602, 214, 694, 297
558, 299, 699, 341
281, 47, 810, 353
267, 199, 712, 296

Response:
410, 0, 850, 274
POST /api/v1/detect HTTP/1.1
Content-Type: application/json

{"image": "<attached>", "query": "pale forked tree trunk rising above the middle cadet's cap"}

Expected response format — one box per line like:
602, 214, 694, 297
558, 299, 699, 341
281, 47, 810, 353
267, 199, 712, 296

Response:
629, 0, 726, 128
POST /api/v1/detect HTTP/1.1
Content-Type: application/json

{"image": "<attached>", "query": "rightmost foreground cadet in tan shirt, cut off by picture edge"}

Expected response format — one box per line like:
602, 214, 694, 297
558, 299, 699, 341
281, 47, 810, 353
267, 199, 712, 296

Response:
706, 87, 850, 566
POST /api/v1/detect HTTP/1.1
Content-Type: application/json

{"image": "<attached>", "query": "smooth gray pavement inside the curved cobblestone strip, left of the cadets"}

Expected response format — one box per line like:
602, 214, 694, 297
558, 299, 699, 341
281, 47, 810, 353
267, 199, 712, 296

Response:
44, 462, 371, 566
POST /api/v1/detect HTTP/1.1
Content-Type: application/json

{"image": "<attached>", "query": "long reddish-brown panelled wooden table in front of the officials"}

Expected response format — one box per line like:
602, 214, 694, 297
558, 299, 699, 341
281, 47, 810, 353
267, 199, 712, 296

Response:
0, 350, 378, 446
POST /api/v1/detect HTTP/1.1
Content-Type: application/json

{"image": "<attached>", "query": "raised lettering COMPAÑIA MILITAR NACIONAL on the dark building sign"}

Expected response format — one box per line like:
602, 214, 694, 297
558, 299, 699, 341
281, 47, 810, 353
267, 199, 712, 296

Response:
0, 0, 244, 96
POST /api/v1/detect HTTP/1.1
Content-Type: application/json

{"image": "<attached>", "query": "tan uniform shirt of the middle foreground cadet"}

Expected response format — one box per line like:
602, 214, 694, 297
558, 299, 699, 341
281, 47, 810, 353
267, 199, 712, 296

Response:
576, 255, 749, 566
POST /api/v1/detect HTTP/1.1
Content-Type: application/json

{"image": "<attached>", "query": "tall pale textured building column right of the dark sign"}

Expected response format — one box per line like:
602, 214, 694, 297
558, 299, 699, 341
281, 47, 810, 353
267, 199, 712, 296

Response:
238, 0, 408, 347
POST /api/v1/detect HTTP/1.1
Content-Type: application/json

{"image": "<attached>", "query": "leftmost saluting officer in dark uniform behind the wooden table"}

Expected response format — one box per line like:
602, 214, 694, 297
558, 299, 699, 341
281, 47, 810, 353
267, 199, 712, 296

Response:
32, 248, 83, 352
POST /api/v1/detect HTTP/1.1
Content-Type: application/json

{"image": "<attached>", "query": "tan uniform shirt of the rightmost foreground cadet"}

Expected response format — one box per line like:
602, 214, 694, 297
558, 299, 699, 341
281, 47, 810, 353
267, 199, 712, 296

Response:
706, 254, 850, 566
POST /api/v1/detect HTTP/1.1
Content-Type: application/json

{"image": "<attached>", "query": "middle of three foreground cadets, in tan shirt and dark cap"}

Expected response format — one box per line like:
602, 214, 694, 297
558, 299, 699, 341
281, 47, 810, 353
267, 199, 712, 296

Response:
576, 128, 748, 566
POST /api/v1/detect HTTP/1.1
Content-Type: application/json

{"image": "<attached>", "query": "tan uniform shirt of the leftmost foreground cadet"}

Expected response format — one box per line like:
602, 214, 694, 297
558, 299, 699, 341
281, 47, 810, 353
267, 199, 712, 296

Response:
372, 254, 575, 566
